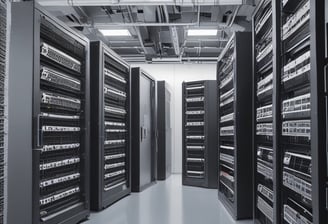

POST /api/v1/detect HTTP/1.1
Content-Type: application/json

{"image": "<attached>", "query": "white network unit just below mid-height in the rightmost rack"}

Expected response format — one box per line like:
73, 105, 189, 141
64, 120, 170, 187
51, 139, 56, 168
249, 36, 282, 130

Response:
282, 120, 311, 138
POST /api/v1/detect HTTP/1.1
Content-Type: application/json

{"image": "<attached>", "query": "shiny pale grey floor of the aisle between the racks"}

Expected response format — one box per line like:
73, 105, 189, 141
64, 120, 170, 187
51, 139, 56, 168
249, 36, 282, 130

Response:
83, 175, 253, 224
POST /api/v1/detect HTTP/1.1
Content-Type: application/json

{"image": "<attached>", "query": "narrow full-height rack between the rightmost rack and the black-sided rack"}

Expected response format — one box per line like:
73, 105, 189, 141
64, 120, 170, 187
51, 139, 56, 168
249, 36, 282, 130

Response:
252, 0, 277, 224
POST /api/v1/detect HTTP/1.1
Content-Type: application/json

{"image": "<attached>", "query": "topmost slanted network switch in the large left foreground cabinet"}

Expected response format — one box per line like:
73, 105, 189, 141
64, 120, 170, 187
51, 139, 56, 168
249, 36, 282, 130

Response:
41, 43, 81, 73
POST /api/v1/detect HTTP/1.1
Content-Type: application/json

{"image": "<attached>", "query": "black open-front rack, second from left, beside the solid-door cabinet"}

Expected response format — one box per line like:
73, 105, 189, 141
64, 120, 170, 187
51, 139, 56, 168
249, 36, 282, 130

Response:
90, 41, 131, 210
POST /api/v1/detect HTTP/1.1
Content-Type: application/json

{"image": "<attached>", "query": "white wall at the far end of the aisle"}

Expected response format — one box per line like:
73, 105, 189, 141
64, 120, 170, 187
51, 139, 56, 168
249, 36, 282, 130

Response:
132, 64, 216, 173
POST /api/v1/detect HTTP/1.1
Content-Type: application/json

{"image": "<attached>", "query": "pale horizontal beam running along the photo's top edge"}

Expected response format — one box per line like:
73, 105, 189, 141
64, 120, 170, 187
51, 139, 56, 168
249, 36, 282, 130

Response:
37, 0, 254, 6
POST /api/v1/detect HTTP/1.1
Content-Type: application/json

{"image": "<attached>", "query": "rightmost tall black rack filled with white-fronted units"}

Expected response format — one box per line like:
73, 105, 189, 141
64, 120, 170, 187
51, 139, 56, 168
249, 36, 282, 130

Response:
276, 0, 313, 223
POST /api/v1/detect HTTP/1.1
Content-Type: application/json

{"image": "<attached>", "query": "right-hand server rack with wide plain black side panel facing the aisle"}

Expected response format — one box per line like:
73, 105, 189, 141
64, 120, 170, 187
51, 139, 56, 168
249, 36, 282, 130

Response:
217, 32, 253, 219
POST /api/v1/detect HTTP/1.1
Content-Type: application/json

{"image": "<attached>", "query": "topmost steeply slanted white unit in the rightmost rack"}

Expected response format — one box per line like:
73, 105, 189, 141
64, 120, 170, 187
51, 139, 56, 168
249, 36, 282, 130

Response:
282, 1, 310, 40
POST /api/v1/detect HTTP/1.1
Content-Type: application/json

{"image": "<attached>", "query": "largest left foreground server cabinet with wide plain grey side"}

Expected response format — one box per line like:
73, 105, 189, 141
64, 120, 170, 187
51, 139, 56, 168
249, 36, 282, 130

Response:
8, 2, 89, 224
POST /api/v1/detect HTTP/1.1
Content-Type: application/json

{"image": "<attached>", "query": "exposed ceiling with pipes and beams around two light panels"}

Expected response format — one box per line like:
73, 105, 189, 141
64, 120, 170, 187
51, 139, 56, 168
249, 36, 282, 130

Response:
38, 0, 258, 63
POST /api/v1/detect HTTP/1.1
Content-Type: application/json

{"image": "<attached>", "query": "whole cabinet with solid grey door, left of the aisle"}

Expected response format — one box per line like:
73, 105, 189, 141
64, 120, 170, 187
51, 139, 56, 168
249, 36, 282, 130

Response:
131, 67, 157, 192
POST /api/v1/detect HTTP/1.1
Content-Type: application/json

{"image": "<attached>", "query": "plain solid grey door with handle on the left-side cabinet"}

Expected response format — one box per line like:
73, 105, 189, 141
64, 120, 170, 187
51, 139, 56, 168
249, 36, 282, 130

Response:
140, 75, 152, 186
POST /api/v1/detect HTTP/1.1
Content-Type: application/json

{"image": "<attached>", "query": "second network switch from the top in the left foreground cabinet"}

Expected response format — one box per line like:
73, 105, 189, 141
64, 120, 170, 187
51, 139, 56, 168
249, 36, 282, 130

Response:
41, 66, 81, 91
